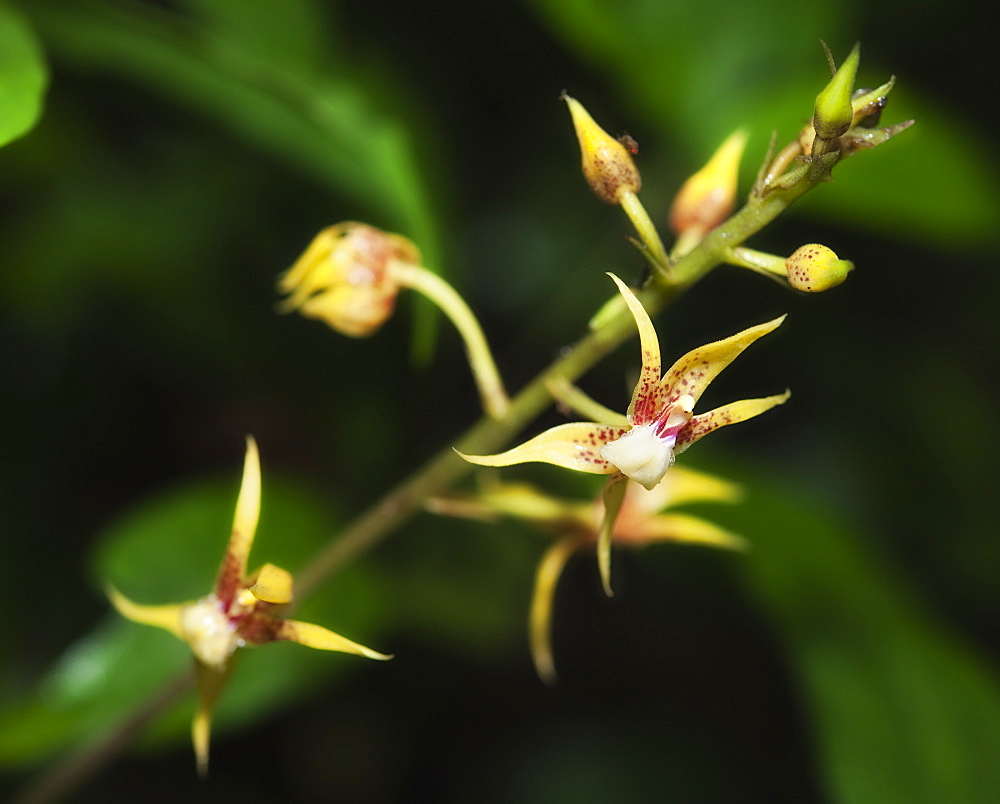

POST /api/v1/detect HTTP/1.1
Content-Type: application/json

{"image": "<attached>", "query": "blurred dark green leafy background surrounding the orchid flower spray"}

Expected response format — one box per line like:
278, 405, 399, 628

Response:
0, 0, 1000, 802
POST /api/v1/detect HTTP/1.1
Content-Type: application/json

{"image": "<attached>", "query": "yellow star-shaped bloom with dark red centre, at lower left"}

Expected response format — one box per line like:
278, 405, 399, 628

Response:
108, 437, 392, 774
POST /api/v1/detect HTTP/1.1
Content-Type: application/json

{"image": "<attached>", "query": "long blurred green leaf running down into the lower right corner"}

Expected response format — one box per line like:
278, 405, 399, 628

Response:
713, 468, 1000, 804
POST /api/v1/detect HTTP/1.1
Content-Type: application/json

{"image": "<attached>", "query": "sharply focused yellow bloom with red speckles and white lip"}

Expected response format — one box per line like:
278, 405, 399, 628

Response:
460, 274, 789, 595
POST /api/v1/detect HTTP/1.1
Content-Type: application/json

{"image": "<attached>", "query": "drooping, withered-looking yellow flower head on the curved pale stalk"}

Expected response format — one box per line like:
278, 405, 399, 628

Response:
278, 221, 420, 338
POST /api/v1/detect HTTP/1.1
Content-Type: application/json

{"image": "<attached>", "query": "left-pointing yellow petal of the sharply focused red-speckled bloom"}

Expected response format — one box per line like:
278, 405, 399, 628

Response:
456, 422, 628, 475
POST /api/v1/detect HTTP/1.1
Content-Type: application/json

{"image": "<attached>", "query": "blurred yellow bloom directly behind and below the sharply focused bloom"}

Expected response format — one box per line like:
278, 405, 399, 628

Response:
428, 466, 745, 683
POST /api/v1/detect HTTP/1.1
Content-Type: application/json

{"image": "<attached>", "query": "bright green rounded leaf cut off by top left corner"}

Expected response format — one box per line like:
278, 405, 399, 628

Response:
0, 3, 48, 146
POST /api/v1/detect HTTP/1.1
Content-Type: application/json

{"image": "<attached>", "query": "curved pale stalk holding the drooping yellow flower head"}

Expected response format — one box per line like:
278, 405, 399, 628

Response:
392, 262, 510, 419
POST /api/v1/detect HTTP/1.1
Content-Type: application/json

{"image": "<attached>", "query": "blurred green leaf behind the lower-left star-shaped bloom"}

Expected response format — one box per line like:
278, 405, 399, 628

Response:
0, 464, 386, 767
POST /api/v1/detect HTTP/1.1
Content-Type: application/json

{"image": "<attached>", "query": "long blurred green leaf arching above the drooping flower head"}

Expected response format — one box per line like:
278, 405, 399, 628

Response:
25, 3, 438, 254
